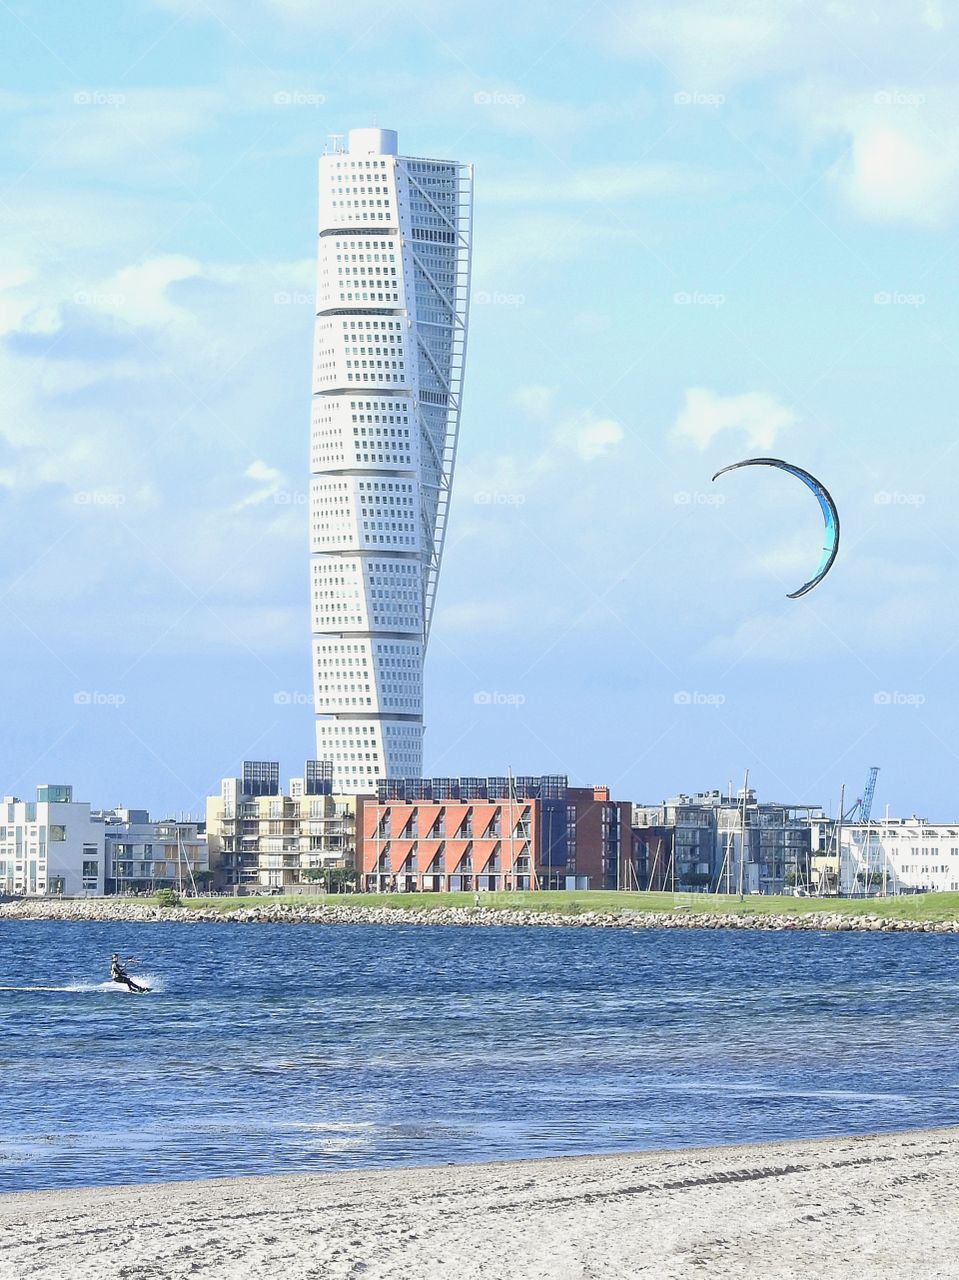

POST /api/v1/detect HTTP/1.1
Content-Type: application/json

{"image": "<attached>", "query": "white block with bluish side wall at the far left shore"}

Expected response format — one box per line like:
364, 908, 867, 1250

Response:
0, 783, 105, 897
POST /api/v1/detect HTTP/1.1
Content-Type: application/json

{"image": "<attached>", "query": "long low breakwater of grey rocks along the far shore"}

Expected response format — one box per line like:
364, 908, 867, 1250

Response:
0, 897, 959, 933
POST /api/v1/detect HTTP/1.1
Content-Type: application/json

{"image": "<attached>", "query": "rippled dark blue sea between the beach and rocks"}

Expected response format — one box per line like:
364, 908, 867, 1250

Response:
0, 922, 959, 1190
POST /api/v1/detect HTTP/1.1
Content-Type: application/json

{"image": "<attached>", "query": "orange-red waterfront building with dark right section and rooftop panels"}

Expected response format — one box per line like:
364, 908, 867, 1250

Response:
356, 776, 633, 892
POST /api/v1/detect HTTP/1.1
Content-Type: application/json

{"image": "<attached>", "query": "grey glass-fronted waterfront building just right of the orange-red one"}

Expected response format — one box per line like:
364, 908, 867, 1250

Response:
633, 788, 821, 893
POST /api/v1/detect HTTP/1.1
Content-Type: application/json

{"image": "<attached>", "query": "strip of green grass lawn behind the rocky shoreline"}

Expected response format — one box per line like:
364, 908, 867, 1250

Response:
170, 890, 959, 922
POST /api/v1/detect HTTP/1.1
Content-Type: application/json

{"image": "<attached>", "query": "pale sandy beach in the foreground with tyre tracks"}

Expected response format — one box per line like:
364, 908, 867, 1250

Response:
0, 1128, 959, 1280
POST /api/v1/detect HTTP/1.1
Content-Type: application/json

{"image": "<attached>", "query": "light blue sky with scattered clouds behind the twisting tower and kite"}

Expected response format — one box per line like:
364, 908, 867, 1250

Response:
0, 0, 959, 820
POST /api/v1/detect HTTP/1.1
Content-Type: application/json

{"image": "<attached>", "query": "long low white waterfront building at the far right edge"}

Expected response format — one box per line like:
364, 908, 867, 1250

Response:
805, 817, 959, 897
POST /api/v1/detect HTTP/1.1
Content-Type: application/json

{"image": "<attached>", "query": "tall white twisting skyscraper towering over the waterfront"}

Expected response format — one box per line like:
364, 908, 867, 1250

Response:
310, 129, 472, 794
